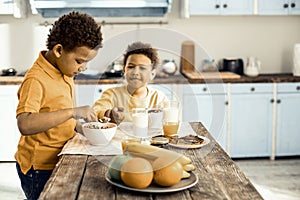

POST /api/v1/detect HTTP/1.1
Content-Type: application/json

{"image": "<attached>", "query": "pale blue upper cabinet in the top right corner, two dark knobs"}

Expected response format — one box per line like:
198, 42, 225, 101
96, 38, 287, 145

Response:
258, 0, 300, 15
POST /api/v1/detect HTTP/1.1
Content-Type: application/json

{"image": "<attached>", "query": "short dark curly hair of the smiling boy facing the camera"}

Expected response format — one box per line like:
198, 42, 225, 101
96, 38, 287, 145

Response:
123, 42, 159, 69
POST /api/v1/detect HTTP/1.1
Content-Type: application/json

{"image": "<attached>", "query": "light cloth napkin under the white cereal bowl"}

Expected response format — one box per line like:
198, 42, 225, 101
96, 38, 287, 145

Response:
58, 130, 124, 156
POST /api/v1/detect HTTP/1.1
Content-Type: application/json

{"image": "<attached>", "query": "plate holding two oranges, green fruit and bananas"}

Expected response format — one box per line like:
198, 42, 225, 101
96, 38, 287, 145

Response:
105, 143, 198, 193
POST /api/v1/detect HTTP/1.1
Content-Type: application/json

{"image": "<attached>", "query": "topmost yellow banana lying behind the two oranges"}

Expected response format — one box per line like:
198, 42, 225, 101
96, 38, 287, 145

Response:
124, 143, 192, 166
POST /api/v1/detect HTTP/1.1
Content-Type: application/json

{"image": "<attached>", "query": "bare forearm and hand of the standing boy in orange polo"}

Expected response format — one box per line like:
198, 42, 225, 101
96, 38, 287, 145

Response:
17, 106, 97, 135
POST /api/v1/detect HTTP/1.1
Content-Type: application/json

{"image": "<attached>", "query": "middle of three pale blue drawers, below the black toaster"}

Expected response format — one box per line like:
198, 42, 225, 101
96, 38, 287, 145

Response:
231, 83, 273, 94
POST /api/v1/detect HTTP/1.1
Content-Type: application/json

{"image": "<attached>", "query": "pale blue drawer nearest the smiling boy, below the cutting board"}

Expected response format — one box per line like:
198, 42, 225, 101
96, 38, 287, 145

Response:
183, 84, 226, 95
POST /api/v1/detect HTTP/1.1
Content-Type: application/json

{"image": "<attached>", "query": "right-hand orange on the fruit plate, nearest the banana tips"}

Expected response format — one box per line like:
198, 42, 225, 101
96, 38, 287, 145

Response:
152, 157, 183, 186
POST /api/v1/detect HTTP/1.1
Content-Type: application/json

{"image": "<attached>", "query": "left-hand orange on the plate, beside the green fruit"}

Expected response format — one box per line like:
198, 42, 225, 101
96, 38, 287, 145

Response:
121, 158, 153, 189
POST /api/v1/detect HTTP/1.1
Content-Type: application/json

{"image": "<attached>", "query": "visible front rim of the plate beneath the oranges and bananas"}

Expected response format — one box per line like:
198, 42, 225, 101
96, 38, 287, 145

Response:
105, 172, 198, 193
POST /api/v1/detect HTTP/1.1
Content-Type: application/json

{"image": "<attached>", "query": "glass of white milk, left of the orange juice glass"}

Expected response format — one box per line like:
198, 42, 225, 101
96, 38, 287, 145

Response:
132, 108, 148, 139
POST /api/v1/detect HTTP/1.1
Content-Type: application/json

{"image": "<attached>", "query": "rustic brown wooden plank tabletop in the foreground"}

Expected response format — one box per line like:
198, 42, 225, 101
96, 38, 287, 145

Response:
40, 122, 263, 200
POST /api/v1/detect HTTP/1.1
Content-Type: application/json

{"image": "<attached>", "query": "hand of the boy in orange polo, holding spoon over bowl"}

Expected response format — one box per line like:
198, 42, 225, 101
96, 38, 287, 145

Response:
73, 106, 98, 122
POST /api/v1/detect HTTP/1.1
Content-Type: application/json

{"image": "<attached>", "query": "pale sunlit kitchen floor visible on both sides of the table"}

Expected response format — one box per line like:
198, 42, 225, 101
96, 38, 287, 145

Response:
0, 159, 300, 200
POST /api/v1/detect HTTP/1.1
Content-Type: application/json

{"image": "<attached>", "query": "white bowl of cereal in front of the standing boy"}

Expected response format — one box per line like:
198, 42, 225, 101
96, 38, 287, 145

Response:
82, 122, 117, 145
